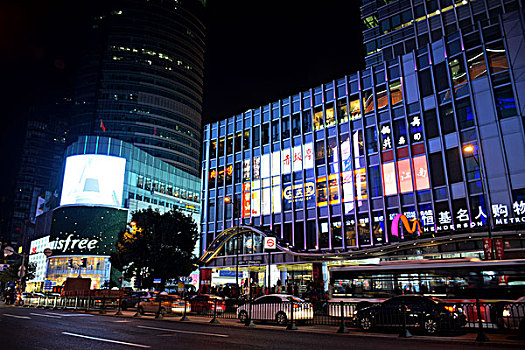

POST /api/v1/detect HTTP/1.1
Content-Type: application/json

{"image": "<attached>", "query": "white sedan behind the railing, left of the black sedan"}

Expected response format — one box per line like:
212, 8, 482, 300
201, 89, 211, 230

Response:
237, 294, 314, 326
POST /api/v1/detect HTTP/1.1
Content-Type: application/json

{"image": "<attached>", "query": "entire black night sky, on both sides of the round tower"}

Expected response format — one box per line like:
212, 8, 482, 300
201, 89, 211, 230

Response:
0, 0, 364, 195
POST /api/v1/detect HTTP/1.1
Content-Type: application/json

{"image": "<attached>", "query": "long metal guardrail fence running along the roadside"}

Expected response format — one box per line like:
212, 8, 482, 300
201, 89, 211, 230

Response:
19, 296, 525, 335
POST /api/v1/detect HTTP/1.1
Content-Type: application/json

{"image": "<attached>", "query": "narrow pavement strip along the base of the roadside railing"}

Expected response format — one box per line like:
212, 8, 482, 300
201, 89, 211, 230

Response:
74, 310, 525, 349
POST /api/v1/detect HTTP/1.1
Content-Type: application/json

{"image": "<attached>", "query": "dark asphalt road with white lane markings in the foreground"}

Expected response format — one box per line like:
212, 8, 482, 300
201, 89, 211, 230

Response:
0, 307, 508, 350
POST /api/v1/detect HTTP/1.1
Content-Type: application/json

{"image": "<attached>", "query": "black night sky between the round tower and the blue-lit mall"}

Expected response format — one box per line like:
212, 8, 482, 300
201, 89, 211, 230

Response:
204, 0, 364, 122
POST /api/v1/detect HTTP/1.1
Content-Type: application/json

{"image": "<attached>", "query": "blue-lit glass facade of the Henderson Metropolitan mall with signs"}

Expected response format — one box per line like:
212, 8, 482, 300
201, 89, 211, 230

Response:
201, 0, 525, 288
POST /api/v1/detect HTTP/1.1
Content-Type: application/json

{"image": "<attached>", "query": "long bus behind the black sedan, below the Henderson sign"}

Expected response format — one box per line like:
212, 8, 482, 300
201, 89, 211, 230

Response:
330, 258, 525, 302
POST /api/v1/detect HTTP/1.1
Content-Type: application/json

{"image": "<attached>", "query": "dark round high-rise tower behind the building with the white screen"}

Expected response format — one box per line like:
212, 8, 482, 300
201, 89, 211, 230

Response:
71, 0, 204, 176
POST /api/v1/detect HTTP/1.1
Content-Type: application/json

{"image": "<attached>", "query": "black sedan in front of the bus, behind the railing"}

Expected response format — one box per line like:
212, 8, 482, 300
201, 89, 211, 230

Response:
355, 295, 466, 334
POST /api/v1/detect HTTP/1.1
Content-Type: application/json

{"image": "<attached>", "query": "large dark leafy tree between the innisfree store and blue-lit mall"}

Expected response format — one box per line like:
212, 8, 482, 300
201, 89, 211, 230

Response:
111, 208, 199, 288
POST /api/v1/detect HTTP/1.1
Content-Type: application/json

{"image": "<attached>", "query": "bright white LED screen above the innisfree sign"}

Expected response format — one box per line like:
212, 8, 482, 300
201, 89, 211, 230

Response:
60, 154, 126, 207
